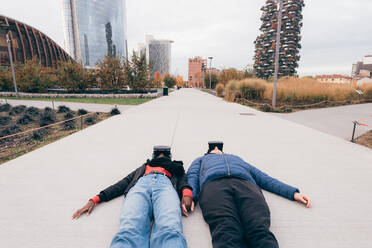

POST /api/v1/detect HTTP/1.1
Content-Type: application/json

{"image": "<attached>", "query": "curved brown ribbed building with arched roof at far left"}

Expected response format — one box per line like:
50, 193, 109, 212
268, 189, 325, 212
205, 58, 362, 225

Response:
0, 15, 73, 67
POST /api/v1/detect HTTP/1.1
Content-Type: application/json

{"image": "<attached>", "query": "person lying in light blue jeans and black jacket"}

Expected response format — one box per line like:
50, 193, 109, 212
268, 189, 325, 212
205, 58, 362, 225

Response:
72, 146, 193, 248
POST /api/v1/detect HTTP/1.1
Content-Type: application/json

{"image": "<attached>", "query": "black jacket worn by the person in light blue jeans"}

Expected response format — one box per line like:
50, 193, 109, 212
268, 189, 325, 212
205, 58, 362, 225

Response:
98, 159, 192, 202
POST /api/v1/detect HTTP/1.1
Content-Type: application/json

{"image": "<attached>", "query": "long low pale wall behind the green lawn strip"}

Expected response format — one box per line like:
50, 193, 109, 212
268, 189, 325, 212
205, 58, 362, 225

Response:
0, 92, 162, 98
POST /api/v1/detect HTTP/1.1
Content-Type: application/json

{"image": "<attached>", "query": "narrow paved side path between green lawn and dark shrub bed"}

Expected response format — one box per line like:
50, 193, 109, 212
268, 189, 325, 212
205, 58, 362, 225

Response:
0, 99, 132, 112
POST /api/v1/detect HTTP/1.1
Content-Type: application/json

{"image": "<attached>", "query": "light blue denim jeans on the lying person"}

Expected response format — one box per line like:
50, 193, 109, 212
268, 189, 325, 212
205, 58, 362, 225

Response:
110, 174, 186, 248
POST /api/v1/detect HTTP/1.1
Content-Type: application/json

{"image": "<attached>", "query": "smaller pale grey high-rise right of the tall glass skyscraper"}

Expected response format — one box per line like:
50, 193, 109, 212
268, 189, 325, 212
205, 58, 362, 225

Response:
145, 35, 173, 76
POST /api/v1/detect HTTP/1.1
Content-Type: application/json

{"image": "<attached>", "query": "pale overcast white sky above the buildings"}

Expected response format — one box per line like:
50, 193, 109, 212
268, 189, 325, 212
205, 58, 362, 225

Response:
0, 0, 372, 79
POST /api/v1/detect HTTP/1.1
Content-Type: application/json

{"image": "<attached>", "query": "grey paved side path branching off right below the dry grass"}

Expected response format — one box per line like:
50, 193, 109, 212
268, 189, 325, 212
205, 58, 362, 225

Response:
274, 103, 372, 140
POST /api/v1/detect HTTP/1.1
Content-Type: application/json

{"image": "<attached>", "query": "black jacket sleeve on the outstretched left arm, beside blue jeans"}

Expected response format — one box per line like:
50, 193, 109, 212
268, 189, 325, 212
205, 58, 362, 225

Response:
98, 167, 141, 202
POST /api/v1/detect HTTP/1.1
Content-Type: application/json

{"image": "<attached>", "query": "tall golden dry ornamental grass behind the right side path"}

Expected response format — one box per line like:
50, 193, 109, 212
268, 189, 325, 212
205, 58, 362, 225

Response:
224, 78, 372, 109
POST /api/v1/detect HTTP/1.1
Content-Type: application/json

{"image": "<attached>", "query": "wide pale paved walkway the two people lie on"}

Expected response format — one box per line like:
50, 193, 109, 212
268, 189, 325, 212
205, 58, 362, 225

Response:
0, 89, 372, 248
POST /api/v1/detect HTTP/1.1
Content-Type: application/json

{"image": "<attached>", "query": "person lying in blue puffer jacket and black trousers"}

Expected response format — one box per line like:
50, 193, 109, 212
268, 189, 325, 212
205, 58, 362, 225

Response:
187, 142, 310, 248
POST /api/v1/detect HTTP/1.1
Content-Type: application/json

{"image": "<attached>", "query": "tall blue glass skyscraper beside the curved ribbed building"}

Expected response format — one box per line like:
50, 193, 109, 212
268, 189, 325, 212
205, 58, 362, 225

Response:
62, 0, 128, 66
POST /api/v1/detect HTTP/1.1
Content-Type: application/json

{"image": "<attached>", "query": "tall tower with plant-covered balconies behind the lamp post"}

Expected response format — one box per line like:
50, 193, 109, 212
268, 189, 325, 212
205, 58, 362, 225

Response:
254, 0, 305, 79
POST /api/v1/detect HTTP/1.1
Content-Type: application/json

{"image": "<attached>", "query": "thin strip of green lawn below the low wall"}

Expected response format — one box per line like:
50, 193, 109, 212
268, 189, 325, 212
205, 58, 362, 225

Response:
0, 97, 155, 105
